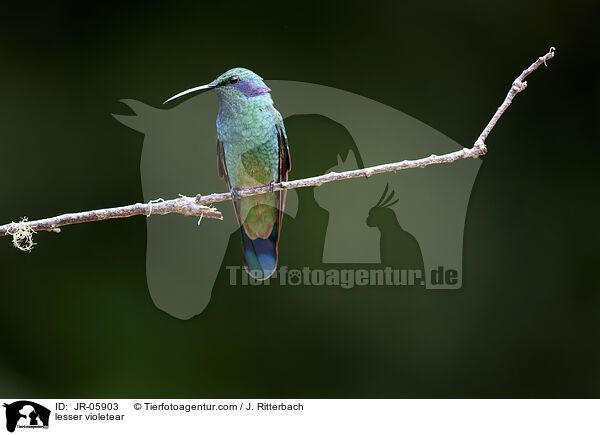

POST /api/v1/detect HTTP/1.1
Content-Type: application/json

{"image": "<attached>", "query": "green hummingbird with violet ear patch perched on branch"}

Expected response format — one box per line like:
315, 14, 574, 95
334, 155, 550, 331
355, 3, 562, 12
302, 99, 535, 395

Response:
163, 68, 291, 280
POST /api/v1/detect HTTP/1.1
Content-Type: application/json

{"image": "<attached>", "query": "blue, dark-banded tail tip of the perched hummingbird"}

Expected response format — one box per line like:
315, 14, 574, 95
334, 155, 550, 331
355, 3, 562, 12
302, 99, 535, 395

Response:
240, 224, 279, 280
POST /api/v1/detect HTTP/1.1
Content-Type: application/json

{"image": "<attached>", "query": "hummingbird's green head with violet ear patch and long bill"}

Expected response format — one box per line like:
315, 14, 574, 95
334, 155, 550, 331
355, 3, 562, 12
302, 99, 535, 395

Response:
163, 68, 271, 104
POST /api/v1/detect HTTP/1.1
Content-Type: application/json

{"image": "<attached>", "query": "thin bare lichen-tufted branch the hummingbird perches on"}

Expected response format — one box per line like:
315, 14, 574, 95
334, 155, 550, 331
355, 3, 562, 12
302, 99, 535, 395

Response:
0, 47, 555, 251
